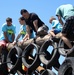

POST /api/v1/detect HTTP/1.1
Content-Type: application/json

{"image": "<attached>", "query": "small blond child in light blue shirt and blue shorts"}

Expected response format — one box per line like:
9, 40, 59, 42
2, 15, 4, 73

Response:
49, 16, 63, 37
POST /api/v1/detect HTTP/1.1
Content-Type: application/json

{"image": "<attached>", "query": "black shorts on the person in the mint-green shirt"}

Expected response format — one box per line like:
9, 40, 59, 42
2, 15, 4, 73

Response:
62, 16, 74, 35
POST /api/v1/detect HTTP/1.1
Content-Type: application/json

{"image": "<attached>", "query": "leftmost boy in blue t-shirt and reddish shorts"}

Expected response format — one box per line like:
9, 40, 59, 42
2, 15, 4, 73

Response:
0, 17, 16, 55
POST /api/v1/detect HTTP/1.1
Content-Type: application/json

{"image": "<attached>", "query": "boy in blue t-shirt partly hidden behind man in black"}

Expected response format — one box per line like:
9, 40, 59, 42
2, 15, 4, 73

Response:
16, 17, 34, 41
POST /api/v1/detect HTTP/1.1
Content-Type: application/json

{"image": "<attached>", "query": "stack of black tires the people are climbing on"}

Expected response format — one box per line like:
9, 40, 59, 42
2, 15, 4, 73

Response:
0, 39, 74, 75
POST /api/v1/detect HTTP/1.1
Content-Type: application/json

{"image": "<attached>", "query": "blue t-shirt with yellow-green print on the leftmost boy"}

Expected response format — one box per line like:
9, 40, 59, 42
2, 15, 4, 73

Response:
0, 23, 16, 42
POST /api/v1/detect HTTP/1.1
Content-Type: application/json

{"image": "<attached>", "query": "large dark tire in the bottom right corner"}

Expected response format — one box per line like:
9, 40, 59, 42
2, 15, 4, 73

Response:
58, 57, 74, 75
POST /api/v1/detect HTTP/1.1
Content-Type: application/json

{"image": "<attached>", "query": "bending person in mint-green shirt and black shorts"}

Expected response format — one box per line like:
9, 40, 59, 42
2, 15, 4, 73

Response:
56, 4, 74, 48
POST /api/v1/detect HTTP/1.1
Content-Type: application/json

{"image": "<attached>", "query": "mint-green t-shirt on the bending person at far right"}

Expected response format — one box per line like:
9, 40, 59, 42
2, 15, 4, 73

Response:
56, 4, 74, 20
